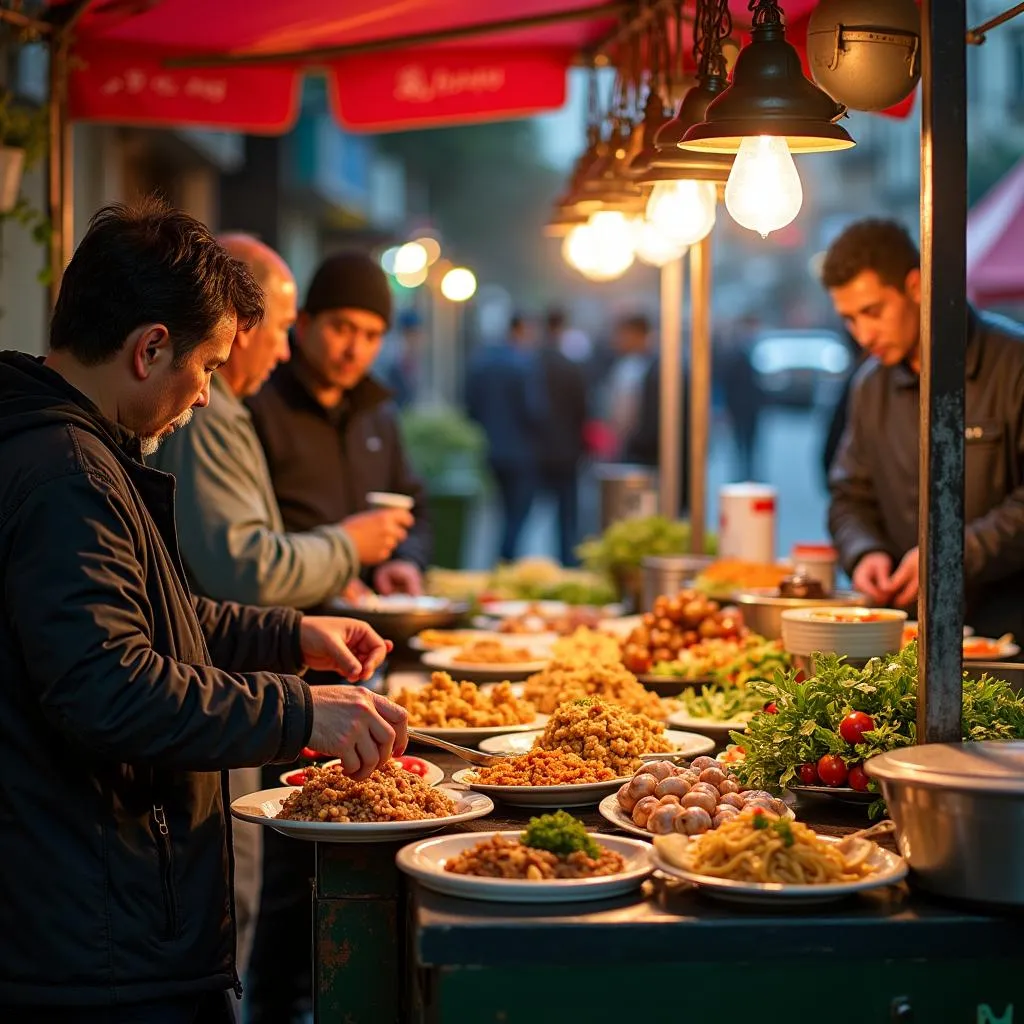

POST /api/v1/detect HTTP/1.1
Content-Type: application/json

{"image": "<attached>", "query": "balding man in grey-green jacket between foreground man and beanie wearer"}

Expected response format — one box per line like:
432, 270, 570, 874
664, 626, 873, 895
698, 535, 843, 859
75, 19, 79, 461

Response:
151, 234, 412, 999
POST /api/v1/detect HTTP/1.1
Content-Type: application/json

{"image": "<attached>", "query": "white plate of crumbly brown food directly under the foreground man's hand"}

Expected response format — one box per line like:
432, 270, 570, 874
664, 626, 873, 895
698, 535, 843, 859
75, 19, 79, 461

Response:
231, 761, 495, 843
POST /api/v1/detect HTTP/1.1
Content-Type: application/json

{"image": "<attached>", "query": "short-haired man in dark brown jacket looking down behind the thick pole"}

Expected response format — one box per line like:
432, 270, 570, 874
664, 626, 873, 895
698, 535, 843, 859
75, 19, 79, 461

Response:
822, 220, 1024, 636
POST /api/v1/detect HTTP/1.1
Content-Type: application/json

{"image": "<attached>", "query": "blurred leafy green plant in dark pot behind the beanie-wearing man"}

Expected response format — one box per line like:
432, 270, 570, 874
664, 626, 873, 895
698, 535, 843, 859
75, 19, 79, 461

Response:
400, 406, 487, 569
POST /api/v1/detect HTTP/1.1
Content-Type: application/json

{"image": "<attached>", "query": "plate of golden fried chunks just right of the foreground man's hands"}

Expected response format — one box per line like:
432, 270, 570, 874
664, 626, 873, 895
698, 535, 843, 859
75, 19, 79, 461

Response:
391, 672, 548, 745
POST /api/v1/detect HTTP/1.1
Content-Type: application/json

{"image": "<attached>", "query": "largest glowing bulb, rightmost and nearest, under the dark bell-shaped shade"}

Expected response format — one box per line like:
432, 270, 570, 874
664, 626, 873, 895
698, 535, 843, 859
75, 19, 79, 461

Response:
725, 135, 804, 239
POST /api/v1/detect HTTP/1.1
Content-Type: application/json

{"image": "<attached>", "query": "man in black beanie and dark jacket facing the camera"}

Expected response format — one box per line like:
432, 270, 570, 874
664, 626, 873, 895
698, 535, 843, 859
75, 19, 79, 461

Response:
248, 253, 431, 1024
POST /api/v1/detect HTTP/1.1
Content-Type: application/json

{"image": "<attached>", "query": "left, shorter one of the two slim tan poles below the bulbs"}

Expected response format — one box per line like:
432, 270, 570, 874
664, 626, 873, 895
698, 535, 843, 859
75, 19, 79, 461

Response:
657, 257, 683, 519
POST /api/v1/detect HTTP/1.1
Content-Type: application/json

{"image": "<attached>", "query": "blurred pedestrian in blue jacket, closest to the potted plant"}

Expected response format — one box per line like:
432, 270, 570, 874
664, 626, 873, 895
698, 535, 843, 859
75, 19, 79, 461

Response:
466, 314, 547, 562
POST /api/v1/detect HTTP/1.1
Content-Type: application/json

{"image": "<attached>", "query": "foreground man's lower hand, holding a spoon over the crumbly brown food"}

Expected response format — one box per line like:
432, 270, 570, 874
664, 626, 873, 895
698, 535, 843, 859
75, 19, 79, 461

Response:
309, 686, 409, 780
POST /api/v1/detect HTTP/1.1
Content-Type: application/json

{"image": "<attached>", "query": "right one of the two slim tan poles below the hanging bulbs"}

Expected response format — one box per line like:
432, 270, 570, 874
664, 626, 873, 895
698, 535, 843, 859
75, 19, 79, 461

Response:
690, 234, 712, 555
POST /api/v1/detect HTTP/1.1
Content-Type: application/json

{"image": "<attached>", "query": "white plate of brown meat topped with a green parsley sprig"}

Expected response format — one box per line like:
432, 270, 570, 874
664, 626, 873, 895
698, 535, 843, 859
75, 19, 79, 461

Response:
396, 811, 652, 903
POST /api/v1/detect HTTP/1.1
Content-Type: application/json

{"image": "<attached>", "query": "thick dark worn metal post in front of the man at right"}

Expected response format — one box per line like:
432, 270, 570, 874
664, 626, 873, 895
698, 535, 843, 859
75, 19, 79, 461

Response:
918, 0, 967, 743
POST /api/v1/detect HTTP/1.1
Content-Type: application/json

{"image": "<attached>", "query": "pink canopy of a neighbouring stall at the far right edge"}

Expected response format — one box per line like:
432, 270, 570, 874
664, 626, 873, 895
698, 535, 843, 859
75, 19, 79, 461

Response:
967, 160, 1024, 306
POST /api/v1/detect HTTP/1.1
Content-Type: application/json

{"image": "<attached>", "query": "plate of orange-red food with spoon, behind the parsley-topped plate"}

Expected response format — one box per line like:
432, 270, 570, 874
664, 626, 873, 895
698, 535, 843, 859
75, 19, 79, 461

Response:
452, 750, 628, 807
